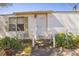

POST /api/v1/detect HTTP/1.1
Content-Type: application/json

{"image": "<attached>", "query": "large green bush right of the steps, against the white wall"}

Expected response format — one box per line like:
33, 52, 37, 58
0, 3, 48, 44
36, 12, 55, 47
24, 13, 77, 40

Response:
55, 32, 74, 48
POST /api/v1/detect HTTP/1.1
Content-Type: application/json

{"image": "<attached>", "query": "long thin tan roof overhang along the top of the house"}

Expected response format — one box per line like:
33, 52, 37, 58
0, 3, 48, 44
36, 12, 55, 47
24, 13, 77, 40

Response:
0, 10, 79, 16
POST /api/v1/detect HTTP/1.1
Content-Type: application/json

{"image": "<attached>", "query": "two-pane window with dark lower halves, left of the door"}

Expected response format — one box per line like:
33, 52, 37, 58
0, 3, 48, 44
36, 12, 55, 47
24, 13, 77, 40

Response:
9, 17, 28, 31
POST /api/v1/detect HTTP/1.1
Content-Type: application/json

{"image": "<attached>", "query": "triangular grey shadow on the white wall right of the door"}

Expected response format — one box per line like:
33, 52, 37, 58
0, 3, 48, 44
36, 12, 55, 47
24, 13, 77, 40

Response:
48, 15, 65, 34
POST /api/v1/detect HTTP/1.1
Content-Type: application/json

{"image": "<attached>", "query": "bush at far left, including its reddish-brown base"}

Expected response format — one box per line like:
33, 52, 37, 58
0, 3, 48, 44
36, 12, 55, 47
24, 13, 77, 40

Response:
0, 37, 21, 55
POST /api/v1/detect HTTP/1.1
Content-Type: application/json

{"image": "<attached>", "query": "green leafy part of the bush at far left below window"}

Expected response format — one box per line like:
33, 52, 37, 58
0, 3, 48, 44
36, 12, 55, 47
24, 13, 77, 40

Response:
0, 37, 21, 50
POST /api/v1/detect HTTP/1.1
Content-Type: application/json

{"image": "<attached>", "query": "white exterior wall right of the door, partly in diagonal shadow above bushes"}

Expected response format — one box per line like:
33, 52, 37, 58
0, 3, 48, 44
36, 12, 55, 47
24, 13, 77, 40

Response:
48, 13, 79, 34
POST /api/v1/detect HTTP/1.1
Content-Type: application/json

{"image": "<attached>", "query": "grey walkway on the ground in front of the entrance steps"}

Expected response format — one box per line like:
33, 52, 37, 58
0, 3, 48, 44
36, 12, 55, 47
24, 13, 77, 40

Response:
31, 47, 53, 56
